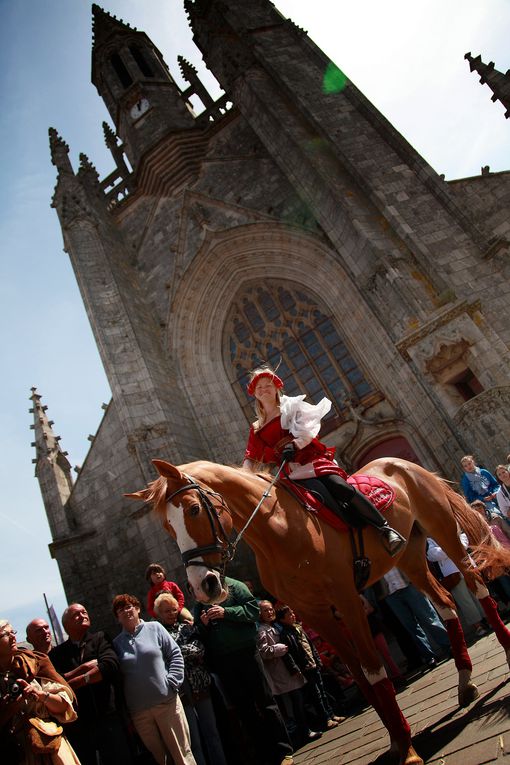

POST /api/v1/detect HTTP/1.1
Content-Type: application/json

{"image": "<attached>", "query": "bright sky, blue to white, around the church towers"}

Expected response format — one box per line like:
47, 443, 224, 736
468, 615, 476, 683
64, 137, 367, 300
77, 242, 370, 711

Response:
0, 0, 510, 630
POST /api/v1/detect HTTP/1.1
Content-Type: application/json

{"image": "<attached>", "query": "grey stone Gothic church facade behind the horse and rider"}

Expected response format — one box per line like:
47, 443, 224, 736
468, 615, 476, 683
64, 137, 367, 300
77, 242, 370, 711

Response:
32, 0, 510, 624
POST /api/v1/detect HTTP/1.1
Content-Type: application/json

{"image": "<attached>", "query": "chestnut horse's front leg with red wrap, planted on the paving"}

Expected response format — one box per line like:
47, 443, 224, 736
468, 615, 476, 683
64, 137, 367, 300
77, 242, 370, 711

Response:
300, 596, 423, 765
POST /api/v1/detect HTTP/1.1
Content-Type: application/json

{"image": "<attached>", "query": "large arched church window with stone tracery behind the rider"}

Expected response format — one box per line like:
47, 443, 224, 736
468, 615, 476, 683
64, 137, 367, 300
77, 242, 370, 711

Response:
225, 280, 379, 433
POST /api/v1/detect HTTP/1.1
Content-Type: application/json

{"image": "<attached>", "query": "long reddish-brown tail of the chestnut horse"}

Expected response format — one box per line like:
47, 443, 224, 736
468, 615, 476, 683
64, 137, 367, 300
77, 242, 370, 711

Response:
443, 482, 510, 579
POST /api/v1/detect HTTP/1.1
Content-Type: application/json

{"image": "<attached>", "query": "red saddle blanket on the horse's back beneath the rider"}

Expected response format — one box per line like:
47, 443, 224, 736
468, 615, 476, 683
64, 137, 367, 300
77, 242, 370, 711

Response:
280, 475, 395, 531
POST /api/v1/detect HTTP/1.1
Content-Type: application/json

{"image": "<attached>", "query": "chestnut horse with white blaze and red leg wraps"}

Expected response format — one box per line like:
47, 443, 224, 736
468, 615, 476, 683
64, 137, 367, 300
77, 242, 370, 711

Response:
127, 458, 510, 765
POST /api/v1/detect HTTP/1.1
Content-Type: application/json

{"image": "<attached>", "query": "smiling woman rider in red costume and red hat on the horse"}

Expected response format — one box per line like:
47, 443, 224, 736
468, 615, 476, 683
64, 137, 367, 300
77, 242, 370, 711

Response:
243, 366, 405, 556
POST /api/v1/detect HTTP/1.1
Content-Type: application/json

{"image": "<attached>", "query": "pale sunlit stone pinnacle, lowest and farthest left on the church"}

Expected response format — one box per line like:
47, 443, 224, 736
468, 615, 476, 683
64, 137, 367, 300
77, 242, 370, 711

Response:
29, 388, 73, 539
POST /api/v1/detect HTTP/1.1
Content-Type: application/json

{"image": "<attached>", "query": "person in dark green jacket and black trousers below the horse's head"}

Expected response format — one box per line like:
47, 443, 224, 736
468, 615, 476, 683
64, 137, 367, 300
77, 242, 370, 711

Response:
195, 577, 294, 765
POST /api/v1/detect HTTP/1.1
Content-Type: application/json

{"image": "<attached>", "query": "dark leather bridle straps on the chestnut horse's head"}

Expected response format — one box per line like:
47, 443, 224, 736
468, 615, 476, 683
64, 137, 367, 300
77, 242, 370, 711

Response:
166, 475, 236, 576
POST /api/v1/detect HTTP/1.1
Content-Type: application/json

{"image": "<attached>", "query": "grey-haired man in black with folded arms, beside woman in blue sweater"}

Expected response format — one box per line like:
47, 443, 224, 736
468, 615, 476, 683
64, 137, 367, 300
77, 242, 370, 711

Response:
49, 603, 132, 765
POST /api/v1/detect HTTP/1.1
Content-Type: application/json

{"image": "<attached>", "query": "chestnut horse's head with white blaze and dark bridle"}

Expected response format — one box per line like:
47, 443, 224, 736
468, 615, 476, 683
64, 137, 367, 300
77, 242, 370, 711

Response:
125, 460, 232, 603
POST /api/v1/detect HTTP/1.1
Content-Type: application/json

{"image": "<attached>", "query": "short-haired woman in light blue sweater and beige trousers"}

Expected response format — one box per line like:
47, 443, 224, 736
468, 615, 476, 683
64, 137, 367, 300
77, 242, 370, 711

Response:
113, 595, 196, 765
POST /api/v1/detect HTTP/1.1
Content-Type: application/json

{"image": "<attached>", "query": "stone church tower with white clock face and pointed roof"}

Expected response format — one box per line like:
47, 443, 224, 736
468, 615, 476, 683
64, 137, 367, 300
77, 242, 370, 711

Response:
92, 4, 194, 166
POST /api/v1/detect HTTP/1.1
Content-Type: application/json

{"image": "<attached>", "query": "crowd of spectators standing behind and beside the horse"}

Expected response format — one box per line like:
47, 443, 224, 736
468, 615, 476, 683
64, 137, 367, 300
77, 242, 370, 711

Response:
0, 455, 510, 765
